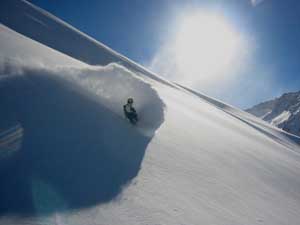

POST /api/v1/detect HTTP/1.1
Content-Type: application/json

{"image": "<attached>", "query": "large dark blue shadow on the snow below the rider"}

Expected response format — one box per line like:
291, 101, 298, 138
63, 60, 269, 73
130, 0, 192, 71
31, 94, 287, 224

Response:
0, 72, 163, 216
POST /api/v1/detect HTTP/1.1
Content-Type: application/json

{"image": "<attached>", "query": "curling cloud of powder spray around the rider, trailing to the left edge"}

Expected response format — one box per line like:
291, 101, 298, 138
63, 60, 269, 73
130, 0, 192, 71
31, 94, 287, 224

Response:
0, 60, 165, 136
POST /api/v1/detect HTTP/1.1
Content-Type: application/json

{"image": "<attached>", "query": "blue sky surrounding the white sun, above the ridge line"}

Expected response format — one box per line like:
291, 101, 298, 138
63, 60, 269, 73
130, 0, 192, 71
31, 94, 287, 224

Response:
30, 0, 300, 108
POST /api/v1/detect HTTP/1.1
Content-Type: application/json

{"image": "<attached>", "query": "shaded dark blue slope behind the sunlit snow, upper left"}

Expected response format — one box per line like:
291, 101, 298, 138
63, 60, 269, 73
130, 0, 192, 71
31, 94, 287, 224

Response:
0, 0, 170, 87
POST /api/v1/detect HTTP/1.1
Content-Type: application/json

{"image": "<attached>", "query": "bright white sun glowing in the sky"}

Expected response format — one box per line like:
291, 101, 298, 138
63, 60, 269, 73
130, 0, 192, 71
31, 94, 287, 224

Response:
174, 12, 242, 82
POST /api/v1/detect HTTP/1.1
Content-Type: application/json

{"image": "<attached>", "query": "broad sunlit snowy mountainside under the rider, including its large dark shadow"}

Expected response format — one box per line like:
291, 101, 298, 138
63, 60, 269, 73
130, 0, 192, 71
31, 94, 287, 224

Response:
0, 1, 300, 225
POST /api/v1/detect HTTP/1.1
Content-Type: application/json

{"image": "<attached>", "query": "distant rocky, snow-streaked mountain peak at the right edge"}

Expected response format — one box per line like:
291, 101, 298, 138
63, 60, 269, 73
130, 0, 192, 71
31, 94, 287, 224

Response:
246, 92, 300, 136
